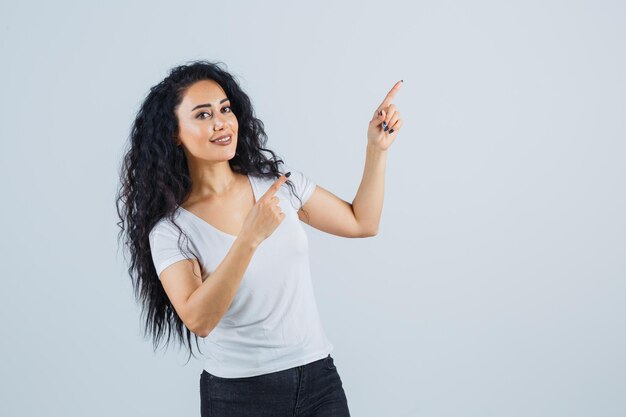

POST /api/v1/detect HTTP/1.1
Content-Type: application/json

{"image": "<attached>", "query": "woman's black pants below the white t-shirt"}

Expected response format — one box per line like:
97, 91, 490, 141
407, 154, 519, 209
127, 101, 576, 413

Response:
200, 355, 350, 417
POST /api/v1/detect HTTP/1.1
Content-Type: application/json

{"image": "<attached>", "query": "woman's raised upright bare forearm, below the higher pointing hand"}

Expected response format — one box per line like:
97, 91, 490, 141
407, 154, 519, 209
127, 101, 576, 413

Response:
352, 146, 387, 234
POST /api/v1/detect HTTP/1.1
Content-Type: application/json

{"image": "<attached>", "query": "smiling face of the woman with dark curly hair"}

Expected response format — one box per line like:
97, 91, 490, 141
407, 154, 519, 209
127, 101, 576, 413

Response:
176, 80, 239, 162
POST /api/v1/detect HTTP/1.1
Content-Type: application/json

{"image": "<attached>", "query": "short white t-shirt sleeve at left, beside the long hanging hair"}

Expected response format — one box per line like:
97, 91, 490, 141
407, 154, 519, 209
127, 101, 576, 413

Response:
149, 220, 196, 279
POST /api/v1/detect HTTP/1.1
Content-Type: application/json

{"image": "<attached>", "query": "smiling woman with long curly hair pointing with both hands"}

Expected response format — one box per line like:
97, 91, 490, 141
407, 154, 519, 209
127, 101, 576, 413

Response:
117, 61, 402, 417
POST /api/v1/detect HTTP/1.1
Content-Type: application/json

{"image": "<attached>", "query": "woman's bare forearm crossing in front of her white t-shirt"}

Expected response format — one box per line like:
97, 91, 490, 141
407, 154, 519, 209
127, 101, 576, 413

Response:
187, 237, 258, 337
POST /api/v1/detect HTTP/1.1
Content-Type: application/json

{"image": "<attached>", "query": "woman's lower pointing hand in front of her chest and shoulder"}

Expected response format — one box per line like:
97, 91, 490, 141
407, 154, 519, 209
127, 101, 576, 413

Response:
239, 173, 289, 247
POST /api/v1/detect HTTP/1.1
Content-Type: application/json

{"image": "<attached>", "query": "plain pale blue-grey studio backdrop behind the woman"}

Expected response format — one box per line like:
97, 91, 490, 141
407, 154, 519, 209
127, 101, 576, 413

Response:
0, 0, 626, 417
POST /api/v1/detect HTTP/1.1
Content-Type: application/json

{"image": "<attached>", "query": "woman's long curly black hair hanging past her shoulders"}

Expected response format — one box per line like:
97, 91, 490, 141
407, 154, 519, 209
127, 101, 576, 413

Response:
116, 61, 306, 357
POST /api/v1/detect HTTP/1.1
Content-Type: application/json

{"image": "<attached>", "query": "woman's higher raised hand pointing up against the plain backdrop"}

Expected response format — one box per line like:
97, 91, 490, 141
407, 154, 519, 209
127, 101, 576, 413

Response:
367, 81, 402, 151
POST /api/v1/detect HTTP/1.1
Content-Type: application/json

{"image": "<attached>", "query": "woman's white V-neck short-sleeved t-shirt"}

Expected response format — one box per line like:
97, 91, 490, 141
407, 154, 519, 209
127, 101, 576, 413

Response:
150, 165, 334, 378
